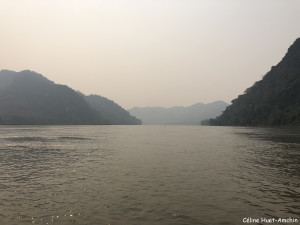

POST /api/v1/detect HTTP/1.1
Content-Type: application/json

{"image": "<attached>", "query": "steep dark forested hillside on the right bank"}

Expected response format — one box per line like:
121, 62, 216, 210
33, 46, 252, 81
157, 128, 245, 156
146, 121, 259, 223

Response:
210, 38, 300, 126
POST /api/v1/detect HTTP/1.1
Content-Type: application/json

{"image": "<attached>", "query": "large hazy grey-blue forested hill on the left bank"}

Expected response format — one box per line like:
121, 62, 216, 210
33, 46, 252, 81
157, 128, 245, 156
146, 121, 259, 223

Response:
0, 70, 140, 124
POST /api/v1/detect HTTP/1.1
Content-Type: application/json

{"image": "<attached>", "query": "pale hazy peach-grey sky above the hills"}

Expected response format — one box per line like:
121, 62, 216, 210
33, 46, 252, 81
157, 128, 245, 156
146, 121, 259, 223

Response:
0, 0, 300, 109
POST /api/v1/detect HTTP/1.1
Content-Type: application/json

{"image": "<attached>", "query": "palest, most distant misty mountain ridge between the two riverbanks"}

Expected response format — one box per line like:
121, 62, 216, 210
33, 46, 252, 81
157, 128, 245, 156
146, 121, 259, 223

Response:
129, 101, 228, 125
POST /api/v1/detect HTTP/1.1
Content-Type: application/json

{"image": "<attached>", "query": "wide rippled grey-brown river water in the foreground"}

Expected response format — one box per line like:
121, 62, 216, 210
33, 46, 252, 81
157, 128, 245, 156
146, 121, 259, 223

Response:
0, 126, 300, 225
